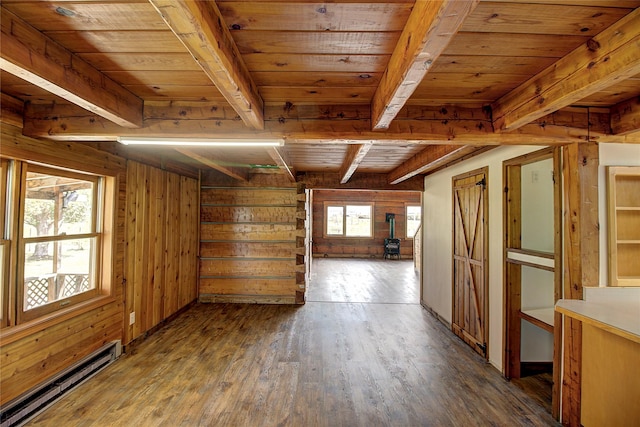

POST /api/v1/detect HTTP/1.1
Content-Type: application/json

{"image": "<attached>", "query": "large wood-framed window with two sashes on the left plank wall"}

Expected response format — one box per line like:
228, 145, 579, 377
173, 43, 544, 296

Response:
0, 160, 113, 326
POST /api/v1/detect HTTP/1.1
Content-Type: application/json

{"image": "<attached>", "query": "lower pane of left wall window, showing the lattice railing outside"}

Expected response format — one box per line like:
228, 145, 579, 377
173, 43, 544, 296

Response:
24, 238, 96, 310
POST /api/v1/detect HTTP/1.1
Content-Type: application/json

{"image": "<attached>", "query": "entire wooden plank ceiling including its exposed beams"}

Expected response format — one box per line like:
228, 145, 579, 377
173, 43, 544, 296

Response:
0, 0, 640, 183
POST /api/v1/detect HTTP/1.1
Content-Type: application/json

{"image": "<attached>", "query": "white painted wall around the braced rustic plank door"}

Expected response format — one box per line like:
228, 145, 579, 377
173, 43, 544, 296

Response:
422, 146, 542, 371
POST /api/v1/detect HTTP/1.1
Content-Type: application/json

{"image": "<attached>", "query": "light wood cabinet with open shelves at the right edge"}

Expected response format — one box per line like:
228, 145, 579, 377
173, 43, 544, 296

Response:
607, 166, 640, 286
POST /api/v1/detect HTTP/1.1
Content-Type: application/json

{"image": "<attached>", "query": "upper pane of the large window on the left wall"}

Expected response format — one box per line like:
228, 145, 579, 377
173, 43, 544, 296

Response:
23, 172, 94, 239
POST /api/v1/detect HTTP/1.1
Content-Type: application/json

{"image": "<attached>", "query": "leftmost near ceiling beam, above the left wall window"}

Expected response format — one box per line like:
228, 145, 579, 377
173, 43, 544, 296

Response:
0, 8, 143, 128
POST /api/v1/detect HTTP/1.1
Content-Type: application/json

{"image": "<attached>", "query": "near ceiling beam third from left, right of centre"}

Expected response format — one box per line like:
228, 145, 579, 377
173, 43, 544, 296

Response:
371, 0, 479, 129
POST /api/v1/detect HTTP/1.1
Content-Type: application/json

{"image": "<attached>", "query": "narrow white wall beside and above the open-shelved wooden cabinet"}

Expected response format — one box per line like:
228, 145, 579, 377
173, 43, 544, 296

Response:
598, 144, 640, 286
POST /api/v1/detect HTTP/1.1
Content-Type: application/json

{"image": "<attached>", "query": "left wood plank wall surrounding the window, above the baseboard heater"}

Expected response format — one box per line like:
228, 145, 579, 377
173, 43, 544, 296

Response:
0, 122, 199, 405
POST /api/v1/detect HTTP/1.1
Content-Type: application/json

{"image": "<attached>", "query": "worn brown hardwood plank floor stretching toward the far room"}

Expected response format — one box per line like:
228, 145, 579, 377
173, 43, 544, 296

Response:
30, 262, 557, 426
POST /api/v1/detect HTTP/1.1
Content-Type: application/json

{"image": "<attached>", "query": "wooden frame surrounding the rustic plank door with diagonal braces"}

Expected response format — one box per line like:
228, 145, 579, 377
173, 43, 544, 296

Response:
451, 166, 489, 360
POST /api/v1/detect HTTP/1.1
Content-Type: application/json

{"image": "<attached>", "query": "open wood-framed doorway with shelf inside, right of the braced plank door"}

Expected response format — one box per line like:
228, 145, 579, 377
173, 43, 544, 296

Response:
503, 148, 562, 418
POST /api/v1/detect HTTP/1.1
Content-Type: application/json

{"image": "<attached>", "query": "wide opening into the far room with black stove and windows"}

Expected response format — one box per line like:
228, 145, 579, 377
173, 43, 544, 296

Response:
306, 189, 422, 304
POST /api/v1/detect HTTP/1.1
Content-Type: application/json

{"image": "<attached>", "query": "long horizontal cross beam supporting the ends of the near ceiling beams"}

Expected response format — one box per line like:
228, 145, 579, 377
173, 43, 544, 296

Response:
22, 104, 640, 145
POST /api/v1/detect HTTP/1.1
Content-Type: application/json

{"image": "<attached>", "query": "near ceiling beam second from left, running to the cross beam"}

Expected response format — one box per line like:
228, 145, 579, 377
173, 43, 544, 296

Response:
149, 0, 264, 129
